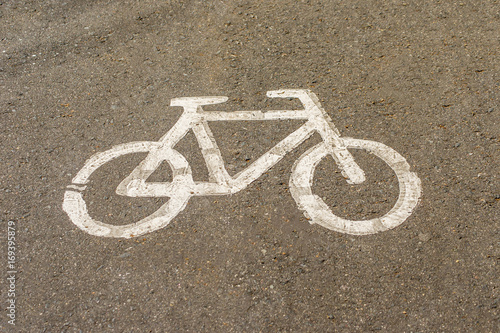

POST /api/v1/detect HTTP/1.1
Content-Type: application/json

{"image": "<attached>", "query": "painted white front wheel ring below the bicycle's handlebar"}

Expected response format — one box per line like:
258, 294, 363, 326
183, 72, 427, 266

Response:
290, 138, 421, 235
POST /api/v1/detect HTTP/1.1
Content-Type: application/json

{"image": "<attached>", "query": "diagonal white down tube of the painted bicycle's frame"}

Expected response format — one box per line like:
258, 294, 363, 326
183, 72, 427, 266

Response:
231, 121, 314, 192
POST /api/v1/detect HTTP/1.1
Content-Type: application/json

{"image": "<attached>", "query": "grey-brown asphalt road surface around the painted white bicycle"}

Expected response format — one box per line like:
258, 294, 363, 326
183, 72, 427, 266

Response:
0, 0, 500, 332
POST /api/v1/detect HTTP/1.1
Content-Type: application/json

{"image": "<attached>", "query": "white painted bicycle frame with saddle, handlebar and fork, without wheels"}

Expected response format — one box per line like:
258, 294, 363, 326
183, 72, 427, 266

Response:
117, 90, 365, 197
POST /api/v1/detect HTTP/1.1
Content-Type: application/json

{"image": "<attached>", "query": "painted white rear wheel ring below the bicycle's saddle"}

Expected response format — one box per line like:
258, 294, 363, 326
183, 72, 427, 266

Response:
63, 141, 194, 238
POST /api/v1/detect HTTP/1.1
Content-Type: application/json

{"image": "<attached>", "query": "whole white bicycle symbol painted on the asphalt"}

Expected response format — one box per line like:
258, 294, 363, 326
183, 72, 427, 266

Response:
63, 89, 421, 238
